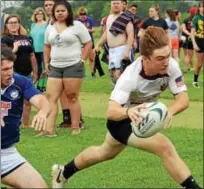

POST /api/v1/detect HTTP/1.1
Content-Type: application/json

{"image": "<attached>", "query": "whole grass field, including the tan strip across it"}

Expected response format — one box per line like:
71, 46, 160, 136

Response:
3, 30, 203, 188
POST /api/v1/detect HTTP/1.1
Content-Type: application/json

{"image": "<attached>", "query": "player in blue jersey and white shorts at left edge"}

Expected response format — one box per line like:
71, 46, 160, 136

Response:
1, 48, 50, 188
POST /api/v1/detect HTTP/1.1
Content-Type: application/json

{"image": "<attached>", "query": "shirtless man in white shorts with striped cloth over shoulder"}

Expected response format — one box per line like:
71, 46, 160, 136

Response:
95, 0, 134, 81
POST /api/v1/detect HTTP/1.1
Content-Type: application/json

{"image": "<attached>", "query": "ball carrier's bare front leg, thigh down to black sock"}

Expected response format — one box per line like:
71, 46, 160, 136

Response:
128, 133, 199, 188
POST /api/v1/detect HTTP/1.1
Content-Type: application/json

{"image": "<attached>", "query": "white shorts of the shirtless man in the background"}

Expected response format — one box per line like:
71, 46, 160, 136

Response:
108, 45, 131, 70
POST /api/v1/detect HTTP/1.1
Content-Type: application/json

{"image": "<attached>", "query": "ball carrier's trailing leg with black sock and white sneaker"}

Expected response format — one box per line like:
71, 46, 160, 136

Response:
52, 132, 125, 188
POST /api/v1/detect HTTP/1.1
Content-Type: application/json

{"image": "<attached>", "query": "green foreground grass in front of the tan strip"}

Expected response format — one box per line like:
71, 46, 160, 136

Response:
18, 116, 203, 188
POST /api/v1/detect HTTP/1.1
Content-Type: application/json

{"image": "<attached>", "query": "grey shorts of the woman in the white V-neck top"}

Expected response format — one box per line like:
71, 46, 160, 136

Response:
48, 62, 85, 79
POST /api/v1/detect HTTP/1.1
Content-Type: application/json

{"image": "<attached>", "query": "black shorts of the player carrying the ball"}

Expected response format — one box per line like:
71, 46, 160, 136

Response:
107, 119, 132, 145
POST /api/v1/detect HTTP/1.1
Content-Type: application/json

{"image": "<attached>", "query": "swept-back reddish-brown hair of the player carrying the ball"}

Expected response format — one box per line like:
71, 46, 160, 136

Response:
140, 26, 169, 57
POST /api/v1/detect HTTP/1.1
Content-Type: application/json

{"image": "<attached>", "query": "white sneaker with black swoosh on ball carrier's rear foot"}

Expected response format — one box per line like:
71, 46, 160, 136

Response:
52, 164, 67, 188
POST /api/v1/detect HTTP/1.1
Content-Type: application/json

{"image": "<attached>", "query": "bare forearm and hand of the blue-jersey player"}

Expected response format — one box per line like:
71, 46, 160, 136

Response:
30, 94, 51, 131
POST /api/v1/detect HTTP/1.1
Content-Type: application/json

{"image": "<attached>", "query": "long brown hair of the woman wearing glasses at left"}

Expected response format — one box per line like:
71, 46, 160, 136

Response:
3, 14, 27, 35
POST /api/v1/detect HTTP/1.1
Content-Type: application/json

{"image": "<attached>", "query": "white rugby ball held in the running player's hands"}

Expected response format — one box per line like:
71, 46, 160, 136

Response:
131, 102, 168, 138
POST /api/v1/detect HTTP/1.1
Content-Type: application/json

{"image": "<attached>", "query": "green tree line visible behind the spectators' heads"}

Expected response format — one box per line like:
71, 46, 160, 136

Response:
3, 0, 197, 30
